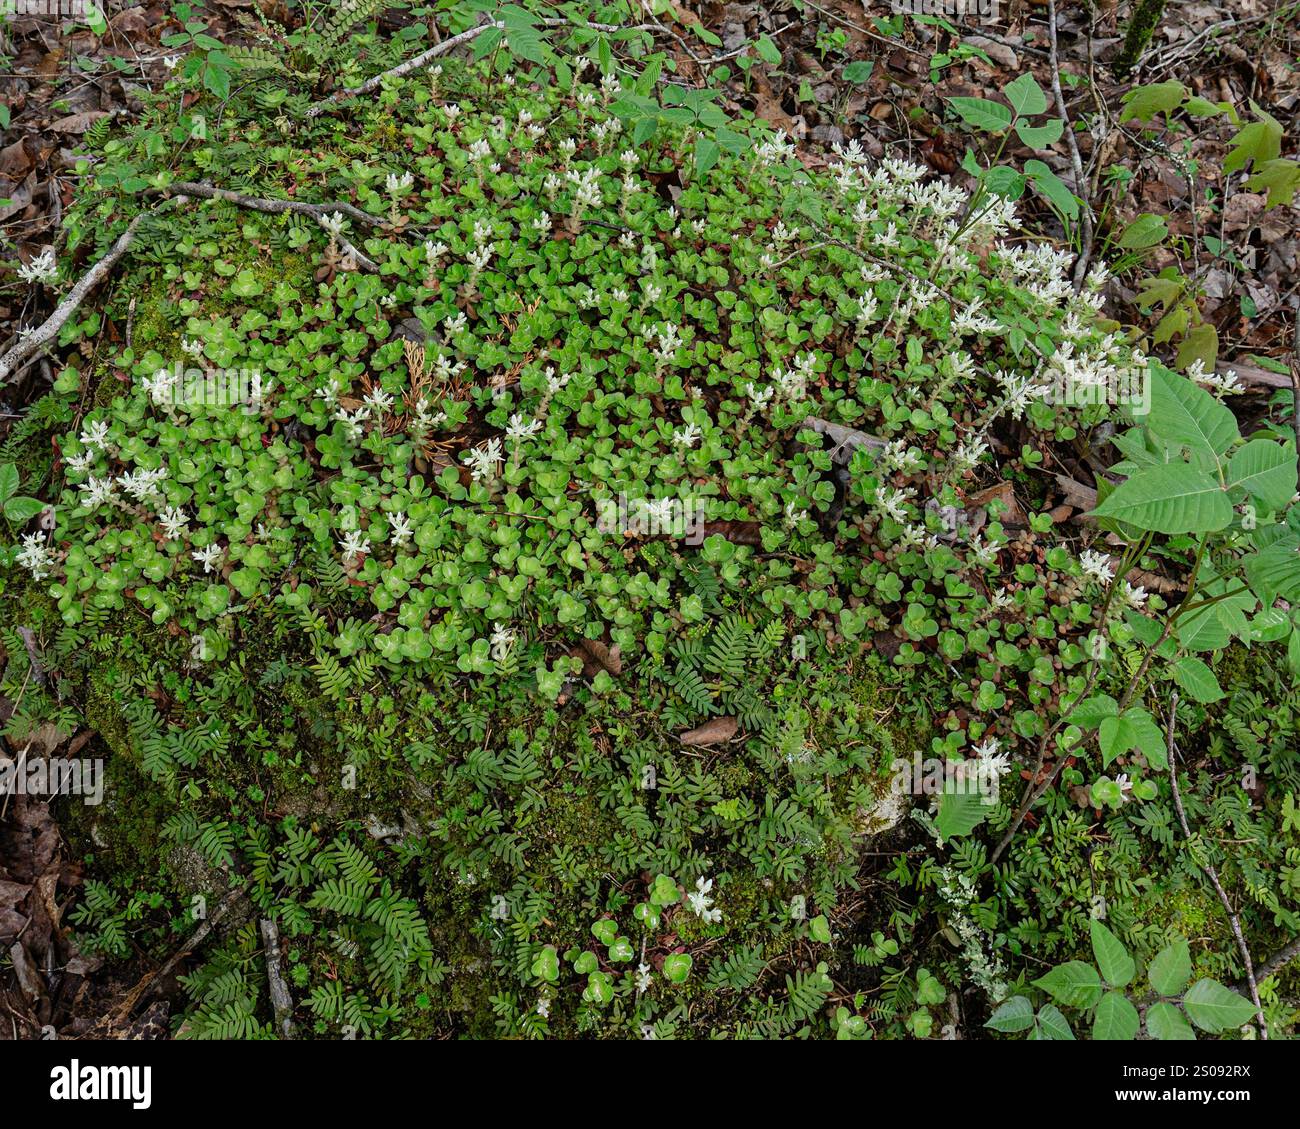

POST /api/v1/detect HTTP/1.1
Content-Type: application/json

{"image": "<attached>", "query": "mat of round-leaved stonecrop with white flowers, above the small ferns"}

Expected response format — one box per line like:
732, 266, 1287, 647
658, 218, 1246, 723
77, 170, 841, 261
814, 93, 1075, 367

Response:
25, 50, 1131, 736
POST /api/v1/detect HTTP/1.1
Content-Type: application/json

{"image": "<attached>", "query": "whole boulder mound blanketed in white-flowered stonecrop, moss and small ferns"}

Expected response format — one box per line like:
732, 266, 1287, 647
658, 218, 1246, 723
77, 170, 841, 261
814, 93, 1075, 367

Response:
5, 8, 1294, 1038
